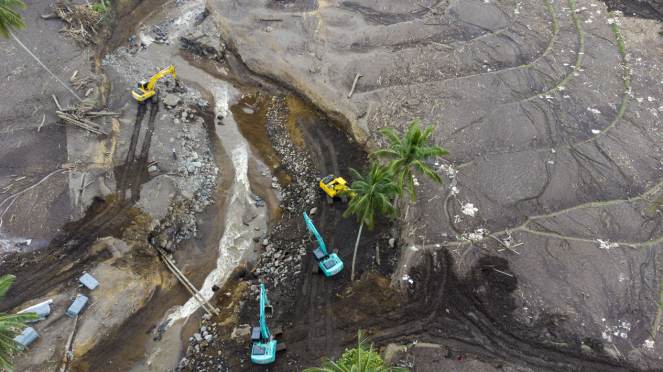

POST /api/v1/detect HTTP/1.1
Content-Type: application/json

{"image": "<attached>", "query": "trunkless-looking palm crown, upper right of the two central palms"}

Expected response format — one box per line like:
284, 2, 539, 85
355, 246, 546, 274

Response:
369, 119, 449, 202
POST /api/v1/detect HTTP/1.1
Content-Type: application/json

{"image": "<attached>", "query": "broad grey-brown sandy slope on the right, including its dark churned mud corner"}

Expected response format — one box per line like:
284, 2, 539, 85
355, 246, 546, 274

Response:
175, 1, 663, 370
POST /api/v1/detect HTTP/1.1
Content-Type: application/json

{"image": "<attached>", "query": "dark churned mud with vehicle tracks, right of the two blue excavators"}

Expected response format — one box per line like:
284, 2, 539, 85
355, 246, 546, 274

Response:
364, 251, 640, 371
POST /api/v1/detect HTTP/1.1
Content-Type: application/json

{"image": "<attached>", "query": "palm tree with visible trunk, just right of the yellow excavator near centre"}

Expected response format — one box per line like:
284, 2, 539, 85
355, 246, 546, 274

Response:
340, 163, 399, 280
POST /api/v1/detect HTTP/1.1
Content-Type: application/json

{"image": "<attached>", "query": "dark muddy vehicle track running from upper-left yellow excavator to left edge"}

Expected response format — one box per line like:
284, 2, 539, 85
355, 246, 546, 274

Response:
0, 104, 159, 311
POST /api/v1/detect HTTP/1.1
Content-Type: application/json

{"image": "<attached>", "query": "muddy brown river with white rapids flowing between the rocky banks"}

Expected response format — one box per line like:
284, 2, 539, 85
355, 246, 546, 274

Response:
98, 0, 324, 371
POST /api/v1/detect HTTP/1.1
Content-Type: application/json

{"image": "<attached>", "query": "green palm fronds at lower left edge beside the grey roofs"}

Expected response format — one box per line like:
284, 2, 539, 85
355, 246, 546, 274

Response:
0, 274, 40, 371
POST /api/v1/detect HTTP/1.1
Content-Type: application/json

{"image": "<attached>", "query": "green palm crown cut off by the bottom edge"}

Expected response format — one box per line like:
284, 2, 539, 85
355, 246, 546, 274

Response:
303, 329, 408, 372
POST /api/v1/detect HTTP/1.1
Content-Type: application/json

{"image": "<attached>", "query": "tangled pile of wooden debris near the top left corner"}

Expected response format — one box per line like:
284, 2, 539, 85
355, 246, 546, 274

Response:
42, 2, 103, 44
